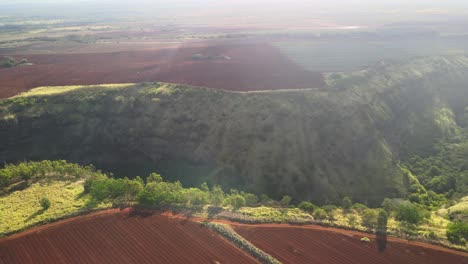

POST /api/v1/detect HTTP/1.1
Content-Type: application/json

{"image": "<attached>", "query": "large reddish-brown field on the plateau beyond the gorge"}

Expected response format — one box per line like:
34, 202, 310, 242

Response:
0, 41, 324, 98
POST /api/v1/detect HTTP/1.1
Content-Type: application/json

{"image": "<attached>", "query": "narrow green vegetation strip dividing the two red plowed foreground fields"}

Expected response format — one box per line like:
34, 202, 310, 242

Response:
202, 222, 281, 264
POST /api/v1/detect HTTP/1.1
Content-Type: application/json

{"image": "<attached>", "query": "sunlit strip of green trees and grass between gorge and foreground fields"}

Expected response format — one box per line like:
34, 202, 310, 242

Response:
0, 160, 468, 251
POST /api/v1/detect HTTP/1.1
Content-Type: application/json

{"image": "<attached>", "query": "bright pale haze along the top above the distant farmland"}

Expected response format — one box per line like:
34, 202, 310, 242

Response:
0, 0, 468, 26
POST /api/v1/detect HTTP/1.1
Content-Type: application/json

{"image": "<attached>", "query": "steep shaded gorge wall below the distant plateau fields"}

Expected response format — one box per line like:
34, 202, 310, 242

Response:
0, 57, 468, 204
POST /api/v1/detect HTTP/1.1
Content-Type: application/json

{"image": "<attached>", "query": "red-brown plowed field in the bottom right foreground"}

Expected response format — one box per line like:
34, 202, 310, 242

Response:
233, 224, 468, 264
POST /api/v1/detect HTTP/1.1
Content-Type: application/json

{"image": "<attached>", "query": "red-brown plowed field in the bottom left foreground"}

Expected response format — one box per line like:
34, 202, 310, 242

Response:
0, 211, 258, 264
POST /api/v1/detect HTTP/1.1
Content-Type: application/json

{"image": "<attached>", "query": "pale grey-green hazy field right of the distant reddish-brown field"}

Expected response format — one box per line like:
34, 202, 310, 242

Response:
273, 37, 468, 72
